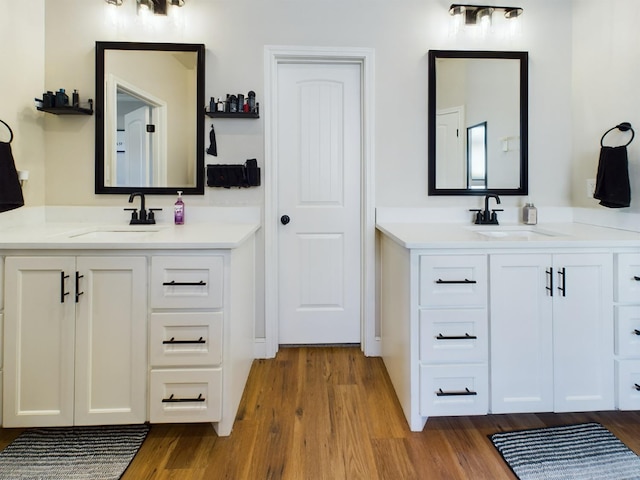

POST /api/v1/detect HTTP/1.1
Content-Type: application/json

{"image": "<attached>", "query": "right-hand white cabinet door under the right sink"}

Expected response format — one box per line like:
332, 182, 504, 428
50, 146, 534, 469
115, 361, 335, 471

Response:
553, 254, 614, 412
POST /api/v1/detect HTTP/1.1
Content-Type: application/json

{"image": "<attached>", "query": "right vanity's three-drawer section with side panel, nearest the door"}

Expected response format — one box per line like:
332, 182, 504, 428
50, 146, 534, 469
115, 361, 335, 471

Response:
380, 236, 489, 430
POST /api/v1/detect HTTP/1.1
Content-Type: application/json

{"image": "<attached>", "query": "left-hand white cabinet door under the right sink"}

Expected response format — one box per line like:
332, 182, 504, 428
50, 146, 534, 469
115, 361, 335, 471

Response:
490, 254, 553, 413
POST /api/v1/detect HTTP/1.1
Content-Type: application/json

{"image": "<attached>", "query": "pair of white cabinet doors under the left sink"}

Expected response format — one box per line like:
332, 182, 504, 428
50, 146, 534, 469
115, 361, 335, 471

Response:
3, 254, 147, 427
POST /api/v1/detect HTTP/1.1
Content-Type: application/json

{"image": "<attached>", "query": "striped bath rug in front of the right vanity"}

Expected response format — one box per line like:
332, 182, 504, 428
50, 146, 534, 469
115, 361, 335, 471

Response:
489, 423, 640, 480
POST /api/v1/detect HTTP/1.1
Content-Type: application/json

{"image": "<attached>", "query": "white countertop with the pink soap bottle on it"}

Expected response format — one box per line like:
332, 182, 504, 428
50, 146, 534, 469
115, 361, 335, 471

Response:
0, 222, 260, 250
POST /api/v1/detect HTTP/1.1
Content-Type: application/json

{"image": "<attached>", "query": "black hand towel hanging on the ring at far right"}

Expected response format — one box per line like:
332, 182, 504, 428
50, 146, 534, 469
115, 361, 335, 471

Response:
593, 146, 631, 208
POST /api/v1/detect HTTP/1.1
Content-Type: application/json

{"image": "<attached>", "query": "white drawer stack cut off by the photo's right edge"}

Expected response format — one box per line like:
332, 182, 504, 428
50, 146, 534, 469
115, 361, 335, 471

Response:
614, 253, 640, 410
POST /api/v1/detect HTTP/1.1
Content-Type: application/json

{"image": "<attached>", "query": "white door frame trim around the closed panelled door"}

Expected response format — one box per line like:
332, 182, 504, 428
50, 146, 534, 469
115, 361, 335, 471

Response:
263, 45, 381, 358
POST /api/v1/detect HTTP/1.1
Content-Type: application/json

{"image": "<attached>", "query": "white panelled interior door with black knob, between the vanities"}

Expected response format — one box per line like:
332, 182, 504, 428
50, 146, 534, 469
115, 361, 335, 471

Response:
274, 63, 362, 344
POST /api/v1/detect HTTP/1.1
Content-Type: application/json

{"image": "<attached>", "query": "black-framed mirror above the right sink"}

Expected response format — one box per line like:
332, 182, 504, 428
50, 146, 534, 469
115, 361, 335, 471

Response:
428, 50, 529, 195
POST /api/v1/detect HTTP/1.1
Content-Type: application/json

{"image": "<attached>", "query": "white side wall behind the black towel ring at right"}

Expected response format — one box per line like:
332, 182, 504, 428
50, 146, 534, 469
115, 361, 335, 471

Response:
571, 0, 640, 214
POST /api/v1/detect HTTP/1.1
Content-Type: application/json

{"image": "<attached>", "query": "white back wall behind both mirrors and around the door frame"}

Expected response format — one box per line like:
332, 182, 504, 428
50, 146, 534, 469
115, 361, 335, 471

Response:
0, 0, 572, 212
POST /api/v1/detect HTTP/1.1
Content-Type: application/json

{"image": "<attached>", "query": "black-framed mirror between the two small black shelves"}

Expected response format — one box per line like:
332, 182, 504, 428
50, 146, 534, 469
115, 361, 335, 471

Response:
95, 42, 205, 195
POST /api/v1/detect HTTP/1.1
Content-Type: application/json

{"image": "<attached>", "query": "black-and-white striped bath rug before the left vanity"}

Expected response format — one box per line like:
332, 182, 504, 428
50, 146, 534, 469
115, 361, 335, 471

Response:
0, 425, 149, 480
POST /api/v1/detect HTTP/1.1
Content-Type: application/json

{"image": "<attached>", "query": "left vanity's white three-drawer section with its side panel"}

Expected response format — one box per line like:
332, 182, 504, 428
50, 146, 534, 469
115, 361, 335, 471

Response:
149, 240, 254, 436
